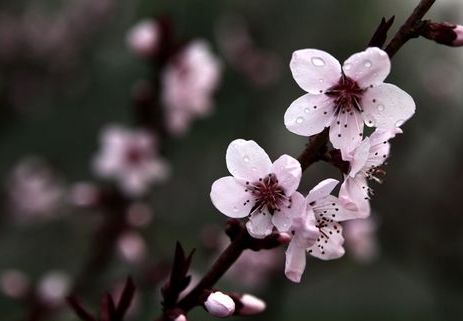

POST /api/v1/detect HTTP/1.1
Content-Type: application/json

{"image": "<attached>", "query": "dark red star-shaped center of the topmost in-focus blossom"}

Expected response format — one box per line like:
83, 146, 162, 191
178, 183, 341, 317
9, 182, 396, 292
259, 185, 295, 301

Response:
325, 75, 365, 115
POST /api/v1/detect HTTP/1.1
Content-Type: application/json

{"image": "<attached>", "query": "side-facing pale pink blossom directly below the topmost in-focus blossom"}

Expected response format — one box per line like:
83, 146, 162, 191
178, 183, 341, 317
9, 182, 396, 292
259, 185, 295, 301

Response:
339, 128, 402, 218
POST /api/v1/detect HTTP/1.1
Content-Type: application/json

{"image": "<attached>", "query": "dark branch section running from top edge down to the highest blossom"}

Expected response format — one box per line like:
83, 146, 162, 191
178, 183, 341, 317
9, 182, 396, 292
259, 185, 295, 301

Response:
385, 0, 436, 58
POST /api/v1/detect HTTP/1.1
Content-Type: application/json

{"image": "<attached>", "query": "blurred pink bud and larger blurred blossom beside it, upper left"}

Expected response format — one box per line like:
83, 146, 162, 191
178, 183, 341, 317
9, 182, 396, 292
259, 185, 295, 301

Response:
127, 19, 222, 136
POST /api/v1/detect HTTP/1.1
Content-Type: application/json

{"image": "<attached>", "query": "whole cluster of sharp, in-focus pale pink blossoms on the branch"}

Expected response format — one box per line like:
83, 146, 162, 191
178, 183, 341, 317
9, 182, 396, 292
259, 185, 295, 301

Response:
211, 48, 415, 282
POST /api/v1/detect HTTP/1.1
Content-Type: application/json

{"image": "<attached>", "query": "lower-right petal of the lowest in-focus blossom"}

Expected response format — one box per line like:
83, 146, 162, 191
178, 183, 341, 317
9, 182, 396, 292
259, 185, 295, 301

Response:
308, 220, 345, 260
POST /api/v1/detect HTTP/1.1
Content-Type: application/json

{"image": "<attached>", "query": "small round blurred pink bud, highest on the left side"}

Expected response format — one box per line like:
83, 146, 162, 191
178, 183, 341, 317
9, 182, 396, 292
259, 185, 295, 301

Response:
127, 20, 160, 57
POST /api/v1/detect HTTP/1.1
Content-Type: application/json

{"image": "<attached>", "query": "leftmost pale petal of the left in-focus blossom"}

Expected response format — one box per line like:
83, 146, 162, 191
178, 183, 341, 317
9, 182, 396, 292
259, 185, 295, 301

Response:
211, 176, 254, 218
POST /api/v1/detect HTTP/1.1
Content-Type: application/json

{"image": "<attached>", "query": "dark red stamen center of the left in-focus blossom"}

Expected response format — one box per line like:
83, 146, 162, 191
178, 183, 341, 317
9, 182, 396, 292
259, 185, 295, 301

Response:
246, 174, 291, 215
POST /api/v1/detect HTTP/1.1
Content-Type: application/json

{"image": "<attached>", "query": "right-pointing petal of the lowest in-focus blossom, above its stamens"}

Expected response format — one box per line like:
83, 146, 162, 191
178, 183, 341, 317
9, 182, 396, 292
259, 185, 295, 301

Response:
313, 195, 362, 222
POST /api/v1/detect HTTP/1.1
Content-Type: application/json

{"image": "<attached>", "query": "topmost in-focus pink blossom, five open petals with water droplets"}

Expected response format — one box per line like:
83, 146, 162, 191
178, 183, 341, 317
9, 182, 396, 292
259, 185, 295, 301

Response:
285, 48, 415, 156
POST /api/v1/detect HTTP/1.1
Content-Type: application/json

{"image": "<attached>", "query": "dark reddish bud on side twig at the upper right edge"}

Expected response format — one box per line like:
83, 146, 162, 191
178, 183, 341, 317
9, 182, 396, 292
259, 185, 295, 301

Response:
421, 21, 463, 47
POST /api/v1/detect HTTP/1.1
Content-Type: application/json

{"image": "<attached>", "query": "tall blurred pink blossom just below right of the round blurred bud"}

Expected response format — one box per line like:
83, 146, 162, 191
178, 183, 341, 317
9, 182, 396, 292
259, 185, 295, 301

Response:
162, 40, 221, 135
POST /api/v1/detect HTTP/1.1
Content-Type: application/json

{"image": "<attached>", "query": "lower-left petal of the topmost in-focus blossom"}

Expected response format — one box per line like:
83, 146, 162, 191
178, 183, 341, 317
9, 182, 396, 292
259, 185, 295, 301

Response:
285, 94, 334, 136
